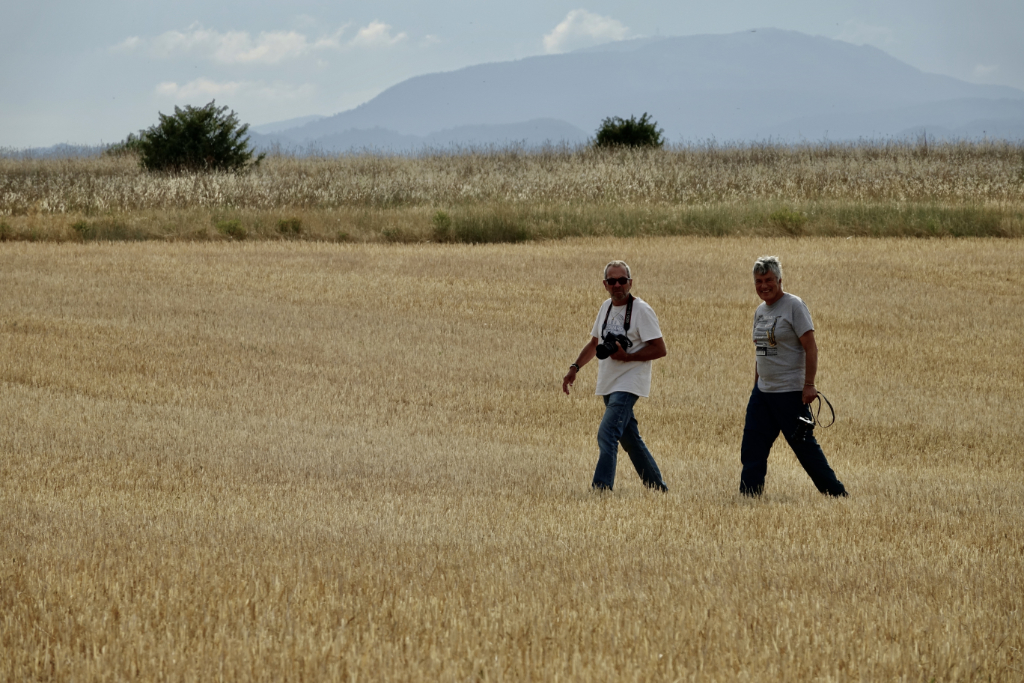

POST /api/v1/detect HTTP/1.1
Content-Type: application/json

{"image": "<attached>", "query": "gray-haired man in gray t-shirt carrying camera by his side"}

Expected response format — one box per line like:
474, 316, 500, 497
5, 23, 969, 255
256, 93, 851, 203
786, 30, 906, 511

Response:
739, 256, 847, 496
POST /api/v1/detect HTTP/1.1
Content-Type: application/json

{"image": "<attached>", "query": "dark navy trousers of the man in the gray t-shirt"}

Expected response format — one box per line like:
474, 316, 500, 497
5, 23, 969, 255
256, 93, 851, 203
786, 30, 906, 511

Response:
739, 386, 846, 496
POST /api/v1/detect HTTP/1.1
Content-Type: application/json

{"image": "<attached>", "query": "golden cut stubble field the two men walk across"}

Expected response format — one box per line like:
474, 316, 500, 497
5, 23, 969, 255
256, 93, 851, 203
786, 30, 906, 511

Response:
0, 238, 1024, 681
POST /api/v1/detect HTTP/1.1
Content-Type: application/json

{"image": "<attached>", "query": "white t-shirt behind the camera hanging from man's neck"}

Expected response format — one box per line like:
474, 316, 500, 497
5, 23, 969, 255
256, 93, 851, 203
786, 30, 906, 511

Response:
591, 297, 662, 396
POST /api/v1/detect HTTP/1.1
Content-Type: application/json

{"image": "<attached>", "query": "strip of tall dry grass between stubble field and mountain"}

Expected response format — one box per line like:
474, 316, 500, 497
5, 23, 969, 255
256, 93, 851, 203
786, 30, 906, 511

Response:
0, 142, 1024, 242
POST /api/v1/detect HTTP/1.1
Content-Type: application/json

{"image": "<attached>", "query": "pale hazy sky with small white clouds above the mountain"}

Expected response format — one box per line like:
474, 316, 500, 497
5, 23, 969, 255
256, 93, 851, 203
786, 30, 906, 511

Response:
0, 0, 1024, 147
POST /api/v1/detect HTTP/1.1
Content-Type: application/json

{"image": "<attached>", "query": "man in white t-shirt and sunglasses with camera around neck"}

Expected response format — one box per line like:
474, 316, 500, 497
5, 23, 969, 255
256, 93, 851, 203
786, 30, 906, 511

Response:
562, 261, 669, 492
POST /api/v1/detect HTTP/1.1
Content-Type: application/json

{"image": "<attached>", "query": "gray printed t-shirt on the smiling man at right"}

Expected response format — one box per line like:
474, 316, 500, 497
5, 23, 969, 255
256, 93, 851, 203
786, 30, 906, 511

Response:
754, 293, 814, 393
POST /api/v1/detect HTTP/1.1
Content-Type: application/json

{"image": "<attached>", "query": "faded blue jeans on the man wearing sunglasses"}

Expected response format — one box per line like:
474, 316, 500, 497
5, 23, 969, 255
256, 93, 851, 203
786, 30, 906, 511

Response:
593, 391, 668, 490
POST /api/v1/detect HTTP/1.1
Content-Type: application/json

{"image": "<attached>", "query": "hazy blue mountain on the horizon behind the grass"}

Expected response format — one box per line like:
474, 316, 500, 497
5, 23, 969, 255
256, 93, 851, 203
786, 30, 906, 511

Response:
254, 29, 1024, 151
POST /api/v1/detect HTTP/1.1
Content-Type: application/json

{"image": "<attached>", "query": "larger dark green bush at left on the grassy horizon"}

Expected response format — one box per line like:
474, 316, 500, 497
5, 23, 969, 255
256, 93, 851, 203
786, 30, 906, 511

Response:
130, 100, 266, 172
